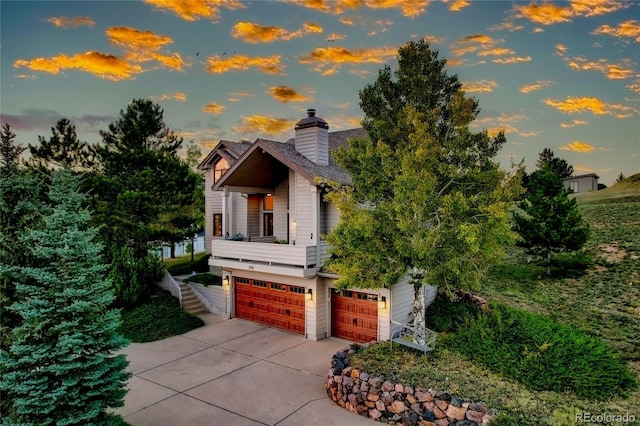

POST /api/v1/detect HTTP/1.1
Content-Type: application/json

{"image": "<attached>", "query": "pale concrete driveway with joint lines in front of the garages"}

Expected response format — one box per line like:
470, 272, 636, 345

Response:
117, 314, 375, 426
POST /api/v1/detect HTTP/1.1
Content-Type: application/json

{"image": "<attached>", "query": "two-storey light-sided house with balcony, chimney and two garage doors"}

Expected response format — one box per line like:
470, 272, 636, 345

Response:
199, 109, 413, 342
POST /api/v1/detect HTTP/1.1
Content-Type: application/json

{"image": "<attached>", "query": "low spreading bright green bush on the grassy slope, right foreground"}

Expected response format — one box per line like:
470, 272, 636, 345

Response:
452, 305, 637, 399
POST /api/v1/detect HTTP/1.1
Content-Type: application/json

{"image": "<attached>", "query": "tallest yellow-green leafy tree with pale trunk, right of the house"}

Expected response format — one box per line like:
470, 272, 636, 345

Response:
326, 40, 518, 343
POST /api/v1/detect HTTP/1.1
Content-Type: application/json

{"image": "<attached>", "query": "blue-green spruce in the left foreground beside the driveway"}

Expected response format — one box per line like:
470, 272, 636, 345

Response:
0, 170, 130, 425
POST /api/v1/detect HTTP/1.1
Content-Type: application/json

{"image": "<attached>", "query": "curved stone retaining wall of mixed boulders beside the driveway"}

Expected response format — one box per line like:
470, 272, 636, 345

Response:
326, 345, 494, 426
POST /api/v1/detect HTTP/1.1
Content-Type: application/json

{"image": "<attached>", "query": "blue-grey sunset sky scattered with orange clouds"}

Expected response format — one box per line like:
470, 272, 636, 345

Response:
0, 0, 640, 185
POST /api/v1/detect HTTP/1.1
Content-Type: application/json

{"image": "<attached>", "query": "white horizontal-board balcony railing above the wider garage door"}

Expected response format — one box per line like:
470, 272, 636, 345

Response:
211, 240, 316, 273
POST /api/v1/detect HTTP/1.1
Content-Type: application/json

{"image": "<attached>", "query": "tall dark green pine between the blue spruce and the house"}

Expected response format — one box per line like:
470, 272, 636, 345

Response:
95, 99, 200, 257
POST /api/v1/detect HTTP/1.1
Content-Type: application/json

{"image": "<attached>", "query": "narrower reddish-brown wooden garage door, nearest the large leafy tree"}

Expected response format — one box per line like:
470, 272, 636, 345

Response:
331, 289, 378, 342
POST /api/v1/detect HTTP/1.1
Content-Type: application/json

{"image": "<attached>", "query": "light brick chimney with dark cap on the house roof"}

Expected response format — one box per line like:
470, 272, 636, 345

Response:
295, 109, 329, 166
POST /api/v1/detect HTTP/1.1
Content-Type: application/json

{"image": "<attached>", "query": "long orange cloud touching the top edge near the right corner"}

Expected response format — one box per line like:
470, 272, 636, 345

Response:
515, 0, 628, 25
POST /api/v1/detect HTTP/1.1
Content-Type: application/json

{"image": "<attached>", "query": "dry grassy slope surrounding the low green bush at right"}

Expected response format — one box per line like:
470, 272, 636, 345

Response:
352, 175, 640, 426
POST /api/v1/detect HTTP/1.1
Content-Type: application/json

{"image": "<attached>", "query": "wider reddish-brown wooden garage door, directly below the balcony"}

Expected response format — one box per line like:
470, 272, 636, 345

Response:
234, 277, 304, 334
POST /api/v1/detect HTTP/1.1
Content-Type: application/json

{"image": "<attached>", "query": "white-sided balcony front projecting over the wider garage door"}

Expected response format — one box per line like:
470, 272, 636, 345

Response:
209, 240, 316, 278
